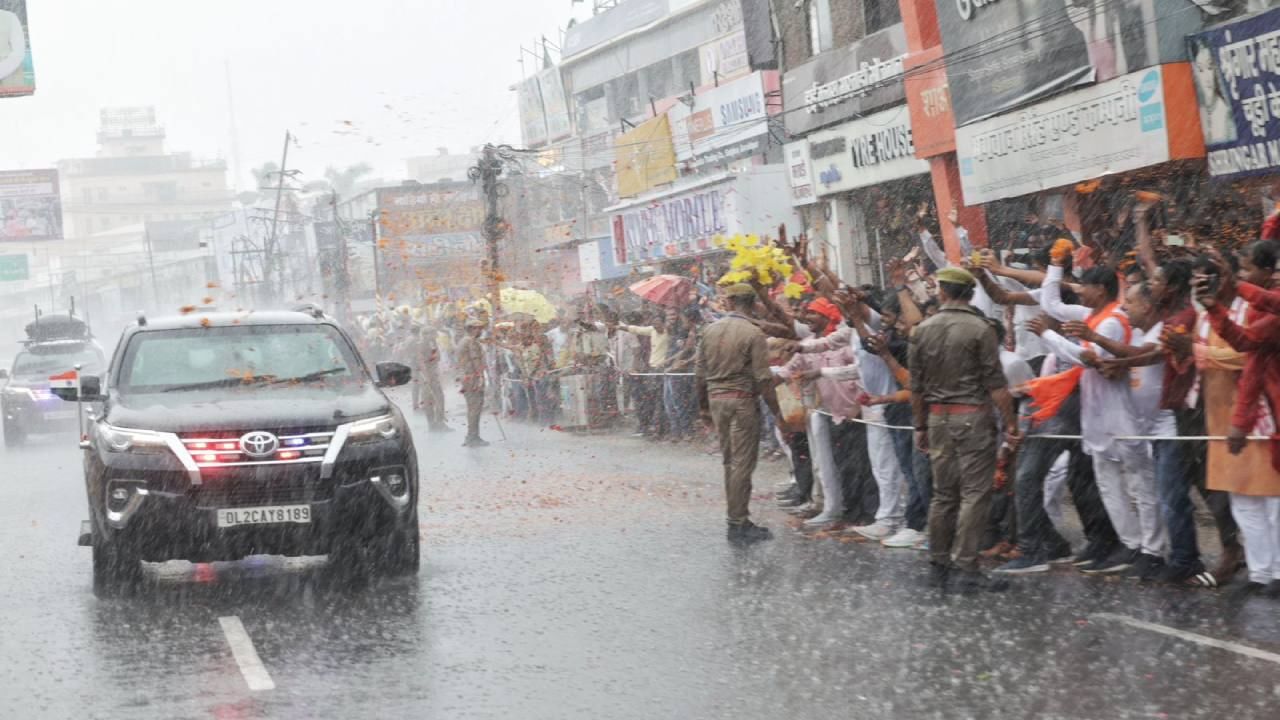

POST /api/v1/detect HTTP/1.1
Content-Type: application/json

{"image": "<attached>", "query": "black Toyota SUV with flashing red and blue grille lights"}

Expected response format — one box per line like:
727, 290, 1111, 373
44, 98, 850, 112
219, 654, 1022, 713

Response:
55, 304, 419, 594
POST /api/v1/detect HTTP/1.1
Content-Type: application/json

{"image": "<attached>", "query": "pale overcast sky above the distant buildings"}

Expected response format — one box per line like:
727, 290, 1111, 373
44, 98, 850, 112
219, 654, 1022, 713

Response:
0, 0, 589, 186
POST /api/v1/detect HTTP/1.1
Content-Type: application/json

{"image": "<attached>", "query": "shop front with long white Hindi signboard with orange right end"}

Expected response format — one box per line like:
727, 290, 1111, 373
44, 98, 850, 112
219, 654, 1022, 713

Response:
956, 63, 1204, 259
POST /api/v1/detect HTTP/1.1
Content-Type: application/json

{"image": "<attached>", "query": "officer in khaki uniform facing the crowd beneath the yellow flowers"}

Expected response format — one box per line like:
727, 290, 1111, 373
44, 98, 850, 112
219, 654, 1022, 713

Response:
694, 284, 782, 543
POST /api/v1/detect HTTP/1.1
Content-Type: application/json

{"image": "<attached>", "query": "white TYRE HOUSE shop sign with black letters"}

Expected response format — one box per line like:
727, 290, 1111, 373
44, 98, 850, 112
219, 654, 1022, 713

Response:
808, 105, 929, 195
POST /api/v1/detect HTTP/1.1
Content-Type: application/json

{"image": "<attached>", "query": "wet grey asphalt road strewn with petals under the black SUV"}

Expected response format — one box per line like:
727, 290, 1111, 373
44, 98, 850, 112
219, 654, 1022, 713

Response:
0, 389, 1280, 720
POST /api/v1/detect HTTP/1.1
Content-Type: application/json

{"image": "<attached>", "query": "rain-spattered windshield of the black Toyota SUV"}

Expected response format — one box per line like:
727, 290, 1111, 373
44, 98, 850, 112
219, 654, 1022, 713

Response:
118, 325, 365, 393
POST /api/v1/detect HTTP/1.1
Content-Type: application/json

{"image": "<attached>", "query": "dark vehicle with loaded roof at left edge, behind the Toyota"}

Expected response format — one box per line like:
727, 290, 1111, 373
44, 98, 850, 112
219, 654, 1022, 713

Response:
0, 316, 106, 447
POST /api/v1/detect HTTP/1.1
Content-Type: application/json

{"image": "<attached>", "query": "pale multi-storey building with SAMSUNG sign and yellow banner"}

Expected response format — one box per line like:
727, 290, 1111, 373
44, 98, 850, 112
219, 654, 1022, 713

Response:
517, 0, 792, 294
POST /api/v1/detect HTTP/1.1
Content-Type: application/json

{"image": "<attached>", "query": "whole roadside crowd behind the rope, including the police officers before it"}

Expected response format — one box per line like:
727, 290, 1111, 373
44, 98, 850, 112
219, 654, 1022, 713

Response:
345, 193, 1280, 598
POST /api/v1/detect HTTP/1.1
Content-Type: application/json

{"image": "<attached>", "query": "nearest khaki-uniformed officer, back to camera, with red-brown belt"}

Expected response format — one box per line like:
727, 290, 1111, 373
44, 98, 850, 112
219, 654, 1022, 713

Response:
909, 268, 1020, 591
